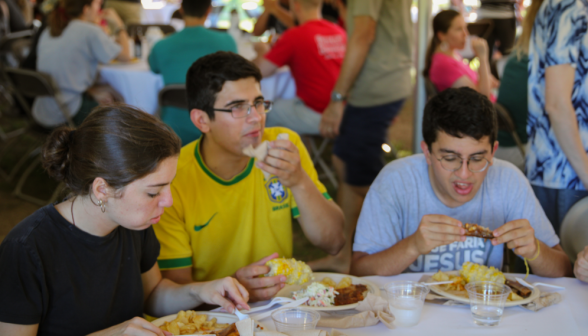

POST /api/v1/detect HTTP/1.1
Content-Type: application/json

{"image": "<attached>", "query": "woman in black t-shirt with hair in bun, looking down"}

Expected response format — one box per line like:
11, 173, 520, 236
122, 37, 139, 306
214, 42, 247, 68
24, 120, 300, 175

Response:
0, 105, 248, 336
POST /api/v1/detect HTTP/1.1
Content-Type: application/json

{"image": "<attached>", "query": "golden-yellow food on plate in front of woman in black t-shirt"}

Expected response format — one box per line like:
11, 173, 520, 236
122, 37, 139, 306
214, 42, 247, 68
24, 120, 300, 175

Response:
159, 310, 230, 336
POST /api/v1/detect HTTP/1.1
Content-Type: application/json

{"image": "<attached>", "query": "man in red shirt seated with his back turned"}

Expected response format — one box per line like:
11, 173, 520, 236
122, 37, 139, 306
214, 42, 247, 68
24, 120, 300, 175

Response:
255, 0, 347, 134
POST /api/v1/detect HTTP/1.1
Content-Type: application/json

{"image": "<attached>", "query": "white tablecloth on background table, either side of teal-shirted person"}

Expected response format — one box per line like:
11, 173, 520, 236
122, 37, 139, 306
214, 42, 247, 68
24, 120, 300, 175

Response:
100, 60, 296, 114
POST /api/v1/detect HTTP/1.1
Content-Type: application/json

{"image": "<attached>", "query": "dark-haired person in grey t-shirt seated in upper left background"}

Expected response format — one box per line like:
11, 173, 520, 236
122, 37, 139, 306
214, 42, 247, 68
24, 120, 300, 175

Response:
33, 0, 130, 127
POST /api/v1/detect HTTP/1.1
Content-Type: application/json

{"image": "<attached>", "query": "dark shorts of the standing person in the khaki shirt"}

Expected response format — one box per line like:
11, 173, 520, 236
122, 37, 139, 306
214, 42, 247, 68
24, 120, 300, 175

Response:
333, 99, 404, 187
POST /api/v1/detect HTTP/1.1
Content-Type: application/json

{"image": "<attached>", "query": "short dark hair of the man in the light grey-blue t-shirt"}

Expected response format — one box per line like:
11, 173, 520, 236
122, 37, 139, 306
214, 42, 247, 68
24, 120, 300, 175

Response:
423, 87, 498, 150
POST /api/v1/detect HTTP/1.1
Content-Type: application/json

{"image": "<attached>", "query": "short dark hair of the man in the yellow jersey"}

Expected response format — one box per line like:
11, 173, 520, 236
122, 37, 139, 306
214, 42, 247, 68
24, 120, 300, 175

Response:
186, 51, 261, 120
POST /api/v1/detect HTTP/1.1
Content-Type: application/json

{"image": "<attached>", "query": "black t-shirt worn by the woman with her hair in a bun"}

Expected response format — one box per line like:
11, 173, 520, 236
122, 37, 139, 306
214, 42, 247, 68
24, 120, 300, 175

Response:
0, 205, 159, 335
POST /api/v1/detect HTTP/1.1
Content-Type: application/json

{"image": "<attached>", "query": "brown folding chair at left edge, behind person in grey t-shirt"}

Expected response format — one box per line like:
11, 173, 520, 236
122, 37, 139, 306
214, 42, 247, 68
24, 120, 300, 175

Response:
2, 68, 75, 205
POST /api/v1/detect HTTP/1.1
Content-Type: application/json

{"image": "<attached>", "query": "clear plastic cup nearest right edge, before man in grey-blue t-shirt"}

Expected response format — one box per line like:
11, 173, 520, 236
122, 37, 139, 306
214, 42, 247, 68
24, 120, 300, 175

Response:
466, 281, 510, 327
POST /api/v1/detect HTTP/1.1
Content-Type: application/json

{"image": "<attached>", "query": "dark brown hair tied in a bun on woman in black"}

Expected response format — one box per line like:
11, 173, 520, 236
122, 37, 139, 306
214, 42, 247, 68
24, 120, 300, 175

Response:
42, 104, 181, 196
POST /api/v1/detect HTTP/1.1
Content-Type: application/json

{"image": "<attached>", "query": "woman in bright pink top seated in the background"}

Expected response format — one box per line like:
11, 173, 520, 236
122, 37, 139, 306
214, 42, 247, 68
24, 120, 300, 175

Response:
423, 10, 498, 101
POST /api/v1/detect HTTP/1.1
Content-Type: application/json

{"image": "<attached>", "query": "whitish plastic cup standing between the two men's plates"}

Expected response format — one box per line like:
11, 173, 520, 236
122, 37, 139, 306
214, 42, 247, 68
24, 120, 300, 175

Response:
386, 281, 429, 327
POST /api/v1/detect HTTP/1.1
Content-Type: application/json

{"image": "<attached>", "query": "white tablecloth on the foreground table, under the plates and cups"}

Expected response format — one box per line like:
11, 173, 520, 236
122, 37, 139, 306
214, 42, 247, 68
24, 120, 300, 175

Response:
254, 273, 588, 336
